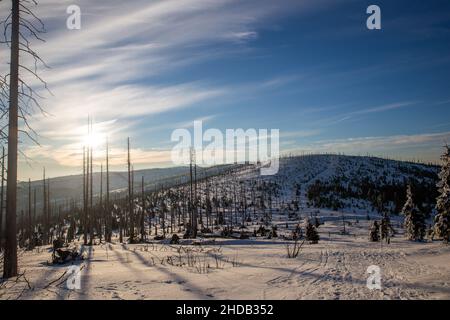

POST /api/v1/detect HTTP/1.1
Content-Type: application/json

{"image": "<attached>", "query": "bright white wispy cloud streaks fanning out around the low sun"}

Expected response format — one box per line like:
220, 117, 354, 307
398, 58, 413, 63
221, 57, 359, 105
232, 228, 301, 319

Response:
0, 0, 318, 178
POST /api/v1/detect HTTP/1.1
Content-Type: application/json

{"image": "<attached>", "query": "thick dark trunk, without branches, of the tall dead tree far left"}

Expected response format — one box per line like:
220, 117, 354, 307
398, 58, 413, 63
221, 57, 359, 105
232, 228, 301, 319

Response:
3, 0, 20, 278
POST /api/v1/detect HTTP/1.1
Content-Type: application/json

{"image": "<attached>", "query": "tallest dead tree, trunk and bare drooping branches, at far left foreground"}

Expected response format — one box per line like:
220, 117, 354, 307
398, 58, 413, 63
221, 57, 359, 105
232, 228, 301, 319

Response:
2, 0, 47, 278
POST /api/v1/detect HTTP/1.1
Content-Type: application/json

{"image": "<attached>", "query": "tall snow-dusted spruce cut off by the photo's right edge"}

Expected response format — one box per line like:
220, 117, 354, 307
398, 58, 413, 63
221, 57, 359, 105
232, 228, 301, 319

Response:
434, 146, 450, 243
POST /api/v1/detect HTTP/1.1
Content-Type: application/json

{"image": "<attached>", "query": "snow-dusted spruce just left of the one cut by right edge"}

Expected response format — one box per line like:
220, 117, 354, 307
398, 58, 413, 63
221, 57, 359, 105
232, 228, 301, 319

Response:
402, 184, 425, 241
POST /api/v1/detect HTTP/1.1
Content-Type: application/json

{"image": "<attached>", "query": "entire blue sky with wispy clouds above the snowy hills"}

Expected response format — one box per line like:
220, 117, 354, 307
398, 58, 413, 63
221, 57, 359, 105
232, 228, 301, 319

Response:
0, 0, 450, 179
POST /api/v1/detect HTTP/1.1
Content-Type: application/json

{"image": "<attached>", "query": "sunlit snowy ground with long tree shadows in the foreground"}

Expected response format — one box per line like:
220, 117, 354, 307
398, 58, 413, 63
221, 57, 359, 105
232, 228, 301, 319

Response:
0, 221, 450, 299
